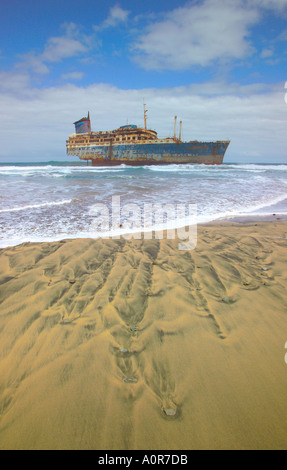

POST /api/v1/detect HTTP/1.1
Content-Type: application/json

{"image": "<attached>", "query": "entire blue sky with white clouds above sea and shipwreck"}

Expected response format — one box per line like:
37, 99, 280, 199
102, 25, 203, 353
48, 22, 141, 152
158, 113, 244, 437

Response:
0, 0, 287, 163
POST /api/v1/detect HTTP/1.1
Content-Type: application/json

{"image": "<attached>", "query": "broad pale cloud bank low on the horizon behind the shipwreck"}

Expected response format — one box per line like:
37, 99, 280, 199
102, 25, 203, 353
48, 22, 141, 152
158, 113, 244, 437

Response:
0, 77, 287, 162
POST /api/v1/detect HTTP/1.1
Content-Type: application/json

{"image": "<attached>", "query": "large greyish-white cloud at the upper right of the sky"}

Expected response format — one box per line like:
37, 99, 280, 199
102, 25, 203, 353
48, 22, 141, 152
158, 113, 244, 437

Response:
134, 0, 259, 70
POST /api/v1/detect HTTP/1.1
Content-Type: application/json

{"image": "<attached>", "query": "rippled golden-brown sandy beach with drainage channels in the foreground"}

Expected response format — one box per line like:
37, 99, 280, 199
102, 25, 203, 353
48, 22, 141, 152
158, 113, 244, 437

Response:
0, 218, 287, 450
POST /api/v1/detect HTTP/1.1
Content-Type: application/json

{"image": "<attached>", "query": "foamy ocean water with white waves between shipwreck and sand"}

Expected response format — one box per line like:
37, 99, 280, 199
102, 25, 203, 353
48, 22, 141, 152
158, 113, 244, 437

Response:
0, 162, 287, 248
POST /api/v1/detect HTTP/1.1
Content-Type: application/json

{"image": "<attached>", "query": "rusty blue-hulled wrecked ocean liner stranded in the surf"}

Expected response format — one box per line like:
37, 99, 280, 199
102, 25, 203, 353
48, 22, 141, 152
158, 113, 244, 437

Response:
66, 114, 230, 166
